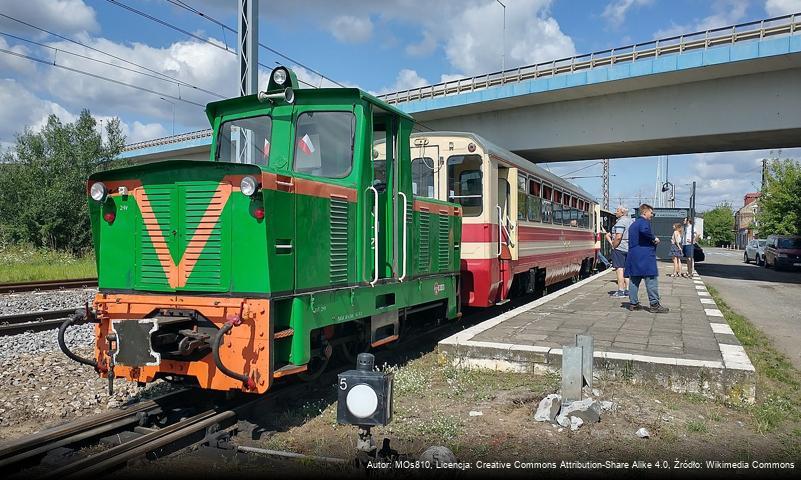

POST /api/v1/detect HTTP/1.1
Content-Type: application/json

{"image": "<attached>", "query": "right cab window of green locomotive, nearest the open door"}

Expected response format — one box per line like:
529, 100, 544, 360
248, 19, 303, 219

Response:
293, 112, 356, 178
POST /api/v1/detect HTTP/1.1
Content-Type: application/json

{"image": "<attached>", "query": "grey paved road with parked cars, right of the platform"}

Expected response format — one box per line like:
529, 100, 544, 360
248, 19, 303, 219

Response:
698, 248, 801, 369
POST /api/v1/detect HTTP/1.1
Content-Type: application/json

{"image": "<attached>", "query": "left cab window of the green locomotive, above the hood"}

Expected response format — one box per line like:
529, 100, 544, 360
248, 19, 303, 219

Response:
216, 115, 273, 165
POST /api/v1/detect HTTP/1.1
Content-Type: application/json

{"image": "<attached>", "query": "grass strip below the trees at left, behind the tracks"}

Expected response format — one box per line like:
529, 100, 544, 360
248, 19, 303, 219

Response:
0, 245, 97, 283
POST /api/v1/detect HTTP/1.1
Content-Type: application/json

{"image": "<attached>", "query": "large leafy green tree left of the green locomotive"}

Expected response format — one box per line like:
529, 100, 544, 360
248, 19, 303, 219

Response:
0, 110, 125, 253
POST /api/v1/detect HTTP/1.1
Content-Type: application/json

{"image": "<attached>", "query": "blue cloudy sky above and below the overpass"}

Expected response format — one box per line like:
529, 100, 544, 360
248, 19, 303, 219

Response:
0, 0, 801, 210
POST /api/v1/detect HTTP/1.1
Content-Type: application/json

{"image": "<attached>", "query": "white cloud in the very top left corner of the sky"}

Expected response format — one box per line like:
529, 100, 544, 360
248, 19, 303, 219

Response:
0, 0, 100, 38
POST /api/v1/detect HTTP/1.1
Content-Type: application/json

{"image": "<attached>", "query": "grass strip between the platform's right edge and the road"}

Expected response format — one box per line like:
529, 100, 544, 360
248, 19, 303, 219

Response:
707, 286, 801, 433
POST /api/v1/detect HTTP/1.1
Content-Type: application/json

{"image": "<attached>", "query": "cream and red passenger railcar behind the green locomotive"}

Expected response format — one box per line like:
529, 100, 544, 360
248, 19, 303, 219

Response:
404, 132, 597, 307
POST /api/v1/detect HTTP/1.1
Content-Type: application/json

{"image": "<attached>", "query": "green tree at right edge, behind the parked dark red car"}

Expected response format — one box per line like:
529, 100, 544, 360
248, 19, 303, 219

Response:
756, 159, 801, 238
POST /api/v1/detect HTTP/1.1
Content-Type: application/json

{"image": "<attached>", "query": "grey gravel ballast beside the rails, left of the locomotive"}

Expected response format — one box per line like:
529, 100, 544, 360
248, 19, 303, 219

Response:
0, 289, 173, 439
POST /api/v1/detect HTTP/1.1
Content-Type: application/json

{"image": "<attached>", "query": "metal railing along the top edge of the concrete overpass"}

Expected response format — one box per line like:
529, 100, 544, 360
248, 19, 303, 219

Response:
378, 13, 801, 104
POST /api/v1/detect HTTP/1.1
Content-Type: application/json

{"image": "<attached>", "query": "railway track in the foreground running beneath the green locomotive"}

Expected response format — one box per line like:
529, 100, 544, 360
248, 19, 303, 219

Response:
0, 274, 588, 479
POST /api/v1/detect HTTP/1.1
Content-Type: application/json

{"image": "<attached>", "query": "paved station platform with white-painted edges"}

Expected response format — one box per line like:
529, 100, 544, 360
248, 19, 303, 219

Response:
438, 262, 756, 403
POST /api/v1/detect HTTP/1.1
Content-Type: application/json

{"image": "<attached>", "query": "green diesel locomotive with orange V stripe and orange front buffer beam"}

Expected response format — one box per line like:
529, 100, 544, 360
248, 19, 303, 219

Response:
59, 67, 464, 393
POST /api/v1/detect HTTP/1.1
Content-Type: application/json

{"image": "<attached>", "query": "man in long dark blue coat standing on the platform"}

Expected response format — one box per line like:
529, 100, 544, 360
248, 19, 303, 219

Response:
623, 203, 669, 313
